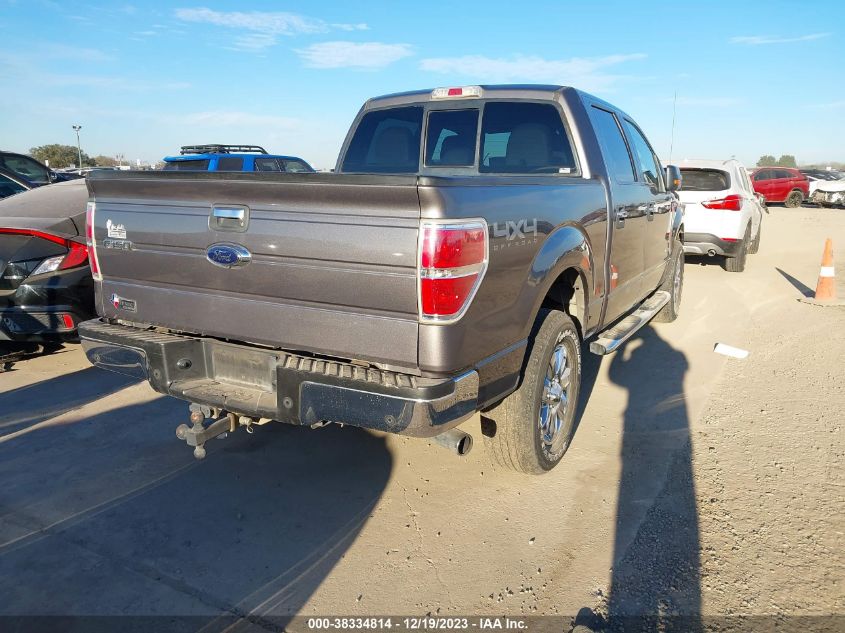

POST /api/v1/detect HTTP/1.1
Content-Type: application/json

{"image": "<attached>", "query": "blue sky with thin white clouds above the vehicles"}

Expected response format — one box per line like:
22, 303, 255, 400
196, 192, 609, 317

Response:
0, 0, 845, 168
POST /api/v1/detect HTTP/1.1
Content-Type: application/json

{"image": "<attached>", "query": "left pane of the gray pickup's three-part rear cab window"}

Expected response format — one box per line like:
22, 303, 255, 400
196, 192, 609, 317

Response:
342, 106, 423, 174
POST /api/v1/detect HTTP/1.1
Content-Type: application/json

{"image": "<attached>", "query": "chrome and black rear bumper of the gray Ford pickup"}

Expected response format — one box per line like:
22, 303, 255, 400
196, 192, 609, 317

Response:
79, 319, 479, 437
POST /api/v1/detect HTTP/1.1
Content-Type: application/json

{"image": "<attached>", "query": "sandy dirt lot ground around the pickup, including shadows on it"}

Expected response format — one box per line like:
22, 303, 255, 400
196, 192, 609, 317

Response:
0, 207, 845, 631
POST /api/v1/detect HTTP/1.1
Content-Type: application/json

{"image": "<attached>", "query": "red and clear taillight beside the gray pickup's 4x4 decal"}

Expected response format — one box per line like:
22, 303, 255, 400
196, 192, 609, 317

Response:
419, 220, 487, 322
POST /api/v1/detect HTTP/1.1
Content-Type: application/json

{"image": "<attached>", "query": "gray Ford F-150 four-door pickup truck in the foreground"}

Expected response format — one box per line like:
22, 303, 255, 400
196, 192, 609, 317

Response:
79, 85, 683, 473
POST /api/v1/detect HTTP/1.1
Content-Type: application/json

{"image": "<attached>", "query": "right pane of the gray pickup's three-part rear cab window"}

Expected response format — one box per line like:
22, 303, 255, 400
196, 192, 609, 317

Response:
478, 101, 576, 174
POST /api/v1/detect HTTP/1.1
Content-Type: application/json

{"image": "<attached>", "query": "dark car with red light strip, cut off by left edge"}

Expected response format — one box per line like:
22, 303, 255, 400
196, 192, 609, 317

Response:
0, 180, 95, 347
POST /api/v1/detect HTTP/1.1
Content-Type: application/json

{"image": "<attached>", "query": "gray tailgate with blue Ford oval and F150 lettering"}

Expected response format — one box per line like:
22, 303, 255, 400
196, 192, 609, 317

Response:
89, 172, 420, 368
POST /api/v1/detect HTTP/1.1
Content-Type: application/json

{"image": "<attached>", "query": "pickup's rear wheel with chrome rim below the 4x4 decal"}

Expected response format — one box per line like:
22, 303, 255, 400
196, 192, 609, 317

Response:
481, 309, 581, 475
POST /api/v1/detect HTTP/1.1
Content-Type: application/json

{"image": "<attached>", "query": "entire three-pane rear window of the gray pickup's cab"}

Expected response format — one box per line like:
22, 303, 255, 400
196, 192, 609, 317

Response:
341, 101, 577, 174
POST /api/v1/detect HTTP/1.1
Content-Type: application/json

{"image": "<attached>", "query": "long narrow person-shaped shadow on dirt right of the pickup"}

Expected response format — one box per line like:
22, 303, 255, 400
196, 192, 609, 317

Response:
575, 326, 701, 632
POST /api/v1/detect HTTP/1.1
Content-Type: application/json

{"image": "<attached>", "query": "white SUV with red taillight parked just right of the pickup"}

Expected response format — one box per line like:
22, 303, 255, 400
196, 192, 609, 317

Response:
678, 159, 765, 273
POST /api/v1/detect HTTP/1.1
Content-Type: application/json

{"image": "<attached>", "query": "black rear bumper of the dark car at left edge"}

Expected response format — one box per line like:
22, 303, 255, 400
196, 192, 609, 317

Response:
0, 266, 95, 343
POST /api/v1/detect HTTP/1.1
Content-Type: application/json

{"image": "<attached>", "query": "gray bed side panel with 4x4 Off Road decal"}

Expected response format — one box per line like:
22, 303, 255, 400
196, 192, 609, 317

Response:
419, 176, 607, 372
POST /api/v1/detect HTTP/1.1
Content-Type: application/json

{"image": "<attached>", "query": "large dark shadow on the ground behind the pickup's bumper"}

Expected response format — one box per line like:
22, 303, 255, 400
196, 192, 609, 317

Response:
0, 397, 392, 631
